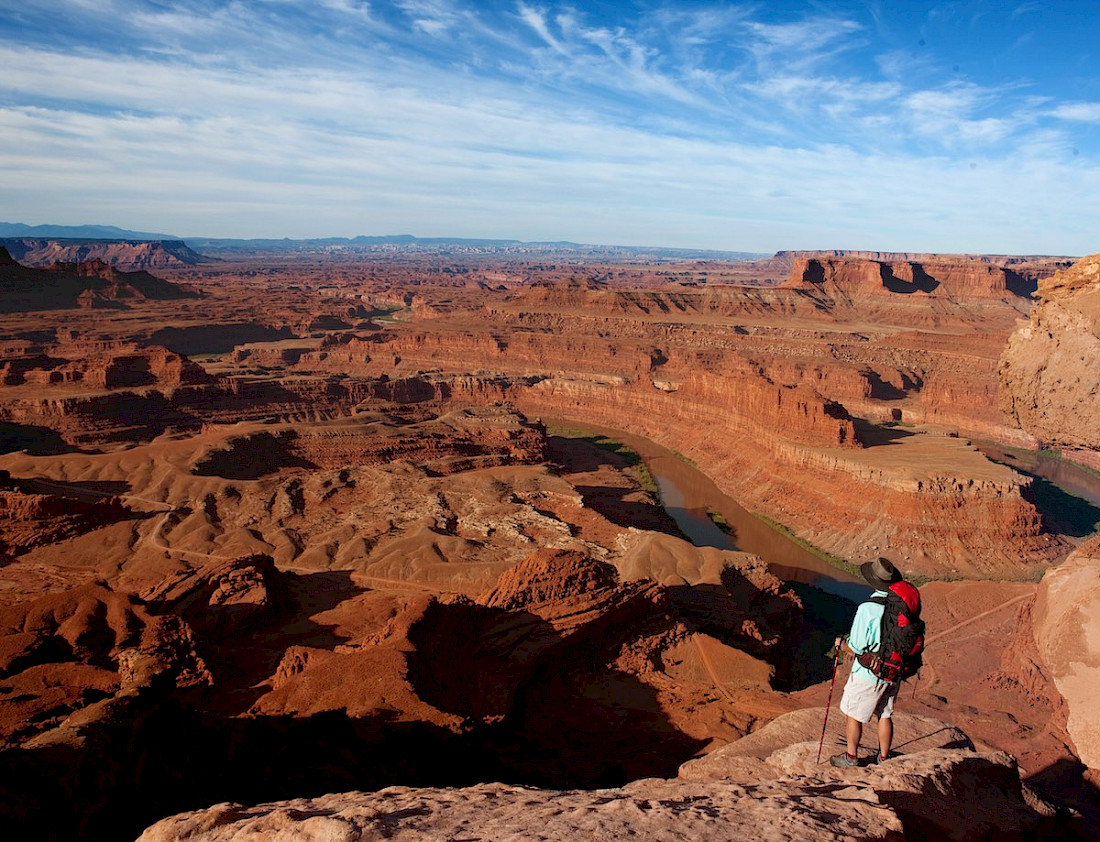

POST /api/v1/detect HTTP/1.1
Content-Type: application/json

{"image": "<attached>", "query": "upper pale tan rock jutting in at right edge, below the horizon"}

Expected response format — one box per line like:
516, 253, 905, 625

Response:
999, 254, 1100, 470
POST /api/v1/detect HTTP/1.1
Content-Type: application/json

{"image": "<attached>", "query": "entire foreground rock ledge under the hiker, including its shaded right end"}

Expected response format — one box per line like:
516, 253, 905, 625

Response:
141, 709, 1073, 842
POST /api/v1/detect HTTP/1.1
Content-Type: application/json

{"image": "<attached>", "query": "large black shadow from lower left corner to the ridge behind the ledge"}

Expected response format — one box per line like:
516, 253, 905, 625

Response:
0, 573, 704, 842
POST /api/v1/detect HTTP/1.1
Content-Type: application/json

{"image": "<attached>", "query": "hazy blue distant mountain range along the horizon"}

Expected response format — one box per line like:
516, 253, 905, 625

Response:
0, 222, 769, 261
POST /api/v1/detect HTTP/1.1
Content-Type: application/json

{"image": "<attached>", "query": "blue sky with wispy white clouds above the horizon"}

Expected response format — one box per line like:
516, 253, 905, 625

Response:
0, 0, 1100, 254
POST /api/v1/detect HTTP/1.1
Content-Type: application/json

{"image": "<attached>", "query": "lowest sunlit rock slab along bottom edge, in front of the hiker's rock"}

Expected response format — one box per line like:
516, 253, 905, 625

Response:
140, 780, 904, 842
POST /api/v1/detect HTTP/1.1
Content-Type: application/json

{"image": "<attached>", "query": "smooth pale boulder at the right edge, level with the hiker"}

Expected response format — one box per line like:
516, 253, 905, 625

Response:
1034, 536, 1100, 769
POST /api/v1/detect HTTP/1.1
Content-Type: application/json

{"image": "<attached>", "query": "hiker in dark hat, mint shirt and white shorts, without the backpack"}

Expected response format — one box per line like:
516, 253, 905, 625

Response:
829, 558, 902, 767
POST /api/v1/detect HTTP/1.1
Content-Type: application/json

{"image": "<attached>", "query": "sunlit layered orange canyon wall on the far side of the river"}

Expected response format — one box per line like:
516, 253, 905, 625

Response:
238, 259, 1067, 576
